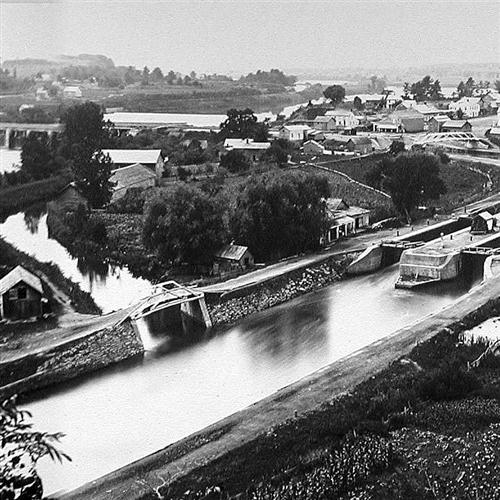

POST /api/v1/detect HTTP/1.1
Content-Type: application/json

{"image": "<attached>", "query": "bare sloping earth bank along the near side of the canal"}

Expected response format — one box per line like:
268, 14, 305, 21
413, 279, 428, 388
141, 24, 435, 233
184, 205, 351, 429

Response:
53, 280, 500, 500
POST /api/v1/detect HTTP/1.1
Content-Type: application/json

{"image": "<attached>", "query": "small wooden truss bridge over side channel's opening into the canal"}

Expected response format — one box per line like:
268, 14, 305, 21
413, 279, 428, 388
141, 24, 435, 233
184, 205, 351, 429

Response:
129, 281, 212, 328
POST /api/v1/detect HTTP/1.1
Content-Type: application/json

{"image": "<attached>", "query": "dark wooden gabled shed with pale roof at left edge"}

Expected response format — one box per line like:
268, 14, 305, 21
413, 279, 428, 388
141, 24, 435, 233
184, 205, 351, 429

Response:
0, 266, 48, 320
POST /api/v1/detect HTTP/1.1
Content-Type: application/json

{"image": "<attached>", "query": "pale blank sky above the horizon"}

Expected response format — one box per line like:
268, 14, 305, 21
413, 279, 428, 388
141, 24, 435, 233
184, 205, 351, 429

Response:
0, 0, 500, 74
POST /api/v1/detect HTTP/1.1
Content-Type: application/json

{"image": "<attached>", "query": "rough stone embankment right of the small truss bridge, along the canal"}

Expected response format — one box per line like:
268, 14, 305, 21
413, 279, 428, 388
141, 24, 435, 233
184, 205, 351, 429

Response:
207, 254, 354, 326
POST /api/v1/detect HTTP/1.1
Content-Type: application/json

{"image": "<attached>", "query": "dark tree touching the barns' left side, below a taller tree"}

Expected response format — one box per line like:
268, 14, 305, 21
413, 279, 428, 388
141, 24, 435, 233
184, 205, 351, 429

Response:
73, 150, 114, 208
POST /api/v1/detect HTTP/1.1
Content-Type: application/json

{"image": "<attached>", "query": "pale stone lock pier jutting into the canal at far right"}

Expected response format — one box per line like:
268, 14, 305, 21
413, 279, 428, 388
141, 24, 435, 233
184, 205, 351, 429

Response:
395, 224, 500, 289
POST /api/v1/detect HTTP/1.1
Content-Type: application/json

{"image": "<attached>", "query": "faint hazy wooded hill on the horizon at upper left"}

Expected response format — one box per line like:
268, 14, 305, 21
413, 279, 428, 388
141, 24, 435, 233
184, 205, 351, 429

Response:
2, 54, 115, 78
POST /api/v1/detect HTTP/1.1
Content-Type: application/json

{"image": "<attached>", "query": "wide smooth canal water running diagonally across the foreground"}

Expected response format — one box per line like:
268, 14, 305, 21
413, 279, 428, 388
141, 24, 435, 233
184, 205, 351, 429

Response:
22, 265, 468, 493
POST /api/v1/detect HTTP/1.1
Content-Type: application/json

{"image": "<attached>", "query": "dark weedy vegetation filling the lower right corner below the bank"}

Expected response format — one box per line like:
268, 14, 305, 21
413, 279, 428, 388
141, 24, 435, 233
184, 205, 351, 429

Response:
159, 300, 500, 500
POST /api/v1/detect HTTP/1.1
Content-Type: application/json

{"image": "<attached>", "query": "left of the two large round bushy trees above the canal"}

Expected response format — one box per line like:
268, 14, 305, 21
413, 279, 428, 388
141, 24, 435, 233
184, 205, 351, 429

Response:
143, 185, 228, 264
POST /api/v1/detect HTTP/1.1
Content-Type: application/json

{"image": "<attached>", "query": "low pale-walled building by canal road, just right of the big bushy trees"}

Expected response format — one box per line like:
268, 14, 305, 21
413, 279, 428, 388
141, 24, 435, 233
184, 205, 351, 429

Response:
322, 198, 370, 245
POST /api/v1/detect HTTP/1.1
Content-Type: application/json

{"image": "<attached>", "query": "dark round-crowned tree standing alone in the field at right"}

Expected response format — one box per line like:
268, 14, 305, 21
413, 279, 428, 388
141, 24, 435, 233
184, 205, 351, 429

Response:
367, 153, 446, 224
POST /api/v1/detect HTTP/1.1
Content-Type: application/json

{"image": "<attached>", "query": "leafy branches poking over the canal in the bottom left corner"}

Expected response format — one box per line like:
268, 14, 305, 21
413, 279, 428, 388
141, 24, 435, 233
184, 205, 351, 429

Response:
0, 398, 71, 500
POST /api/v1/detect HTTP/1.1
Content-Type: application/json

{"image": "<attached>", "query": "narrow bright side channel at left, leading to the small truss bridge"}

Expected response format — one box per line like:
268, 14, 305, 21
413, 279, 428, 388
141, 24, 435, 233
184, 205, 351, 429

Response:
0, 207, 151, 313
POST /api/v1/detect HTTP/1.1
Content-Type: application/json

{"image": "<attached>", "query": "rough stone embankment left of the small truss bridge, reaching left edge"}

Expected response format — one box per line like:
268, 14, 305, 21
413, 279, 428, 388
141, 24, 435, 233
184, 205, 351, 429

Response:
0, 321, 144, 400
